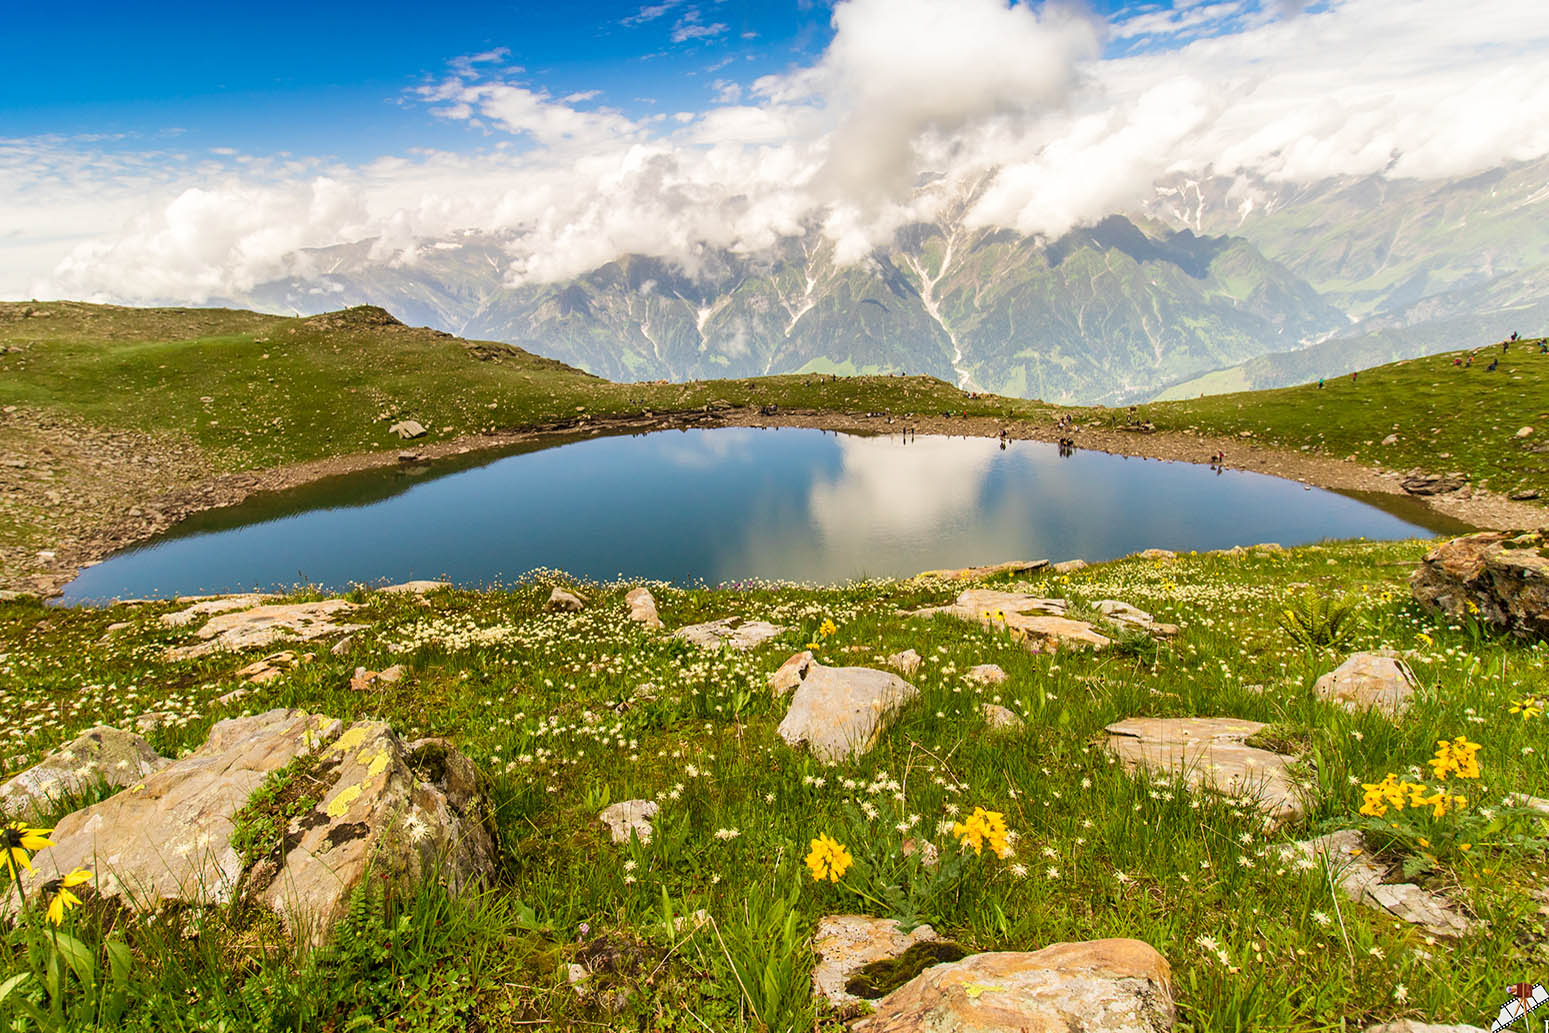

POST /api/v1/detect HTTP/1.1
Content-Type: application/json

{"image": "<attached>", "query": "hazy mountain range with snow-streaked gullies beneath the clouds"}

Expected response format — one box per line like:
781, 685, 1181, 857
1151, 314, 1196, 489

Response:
217, 161, 1549, 404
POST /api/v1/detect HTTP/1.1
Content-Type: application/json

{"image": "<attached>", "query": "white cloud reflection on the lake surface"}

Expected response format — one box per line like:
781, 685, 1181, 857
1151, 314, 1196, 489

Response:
810, 435, 999, 548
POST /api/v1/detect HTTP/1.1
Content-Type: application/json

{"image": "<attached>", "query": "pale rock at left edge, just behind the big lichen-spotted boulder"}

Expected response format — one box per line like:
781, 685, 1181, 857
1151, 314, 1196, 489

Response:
0, 725, 172, 819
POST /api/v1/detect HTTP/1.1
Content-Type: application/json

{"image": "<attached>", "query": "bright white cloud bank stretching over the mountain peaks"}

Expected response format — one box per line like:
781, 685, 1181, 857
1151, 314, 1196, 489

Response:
9, 0, 1549, 302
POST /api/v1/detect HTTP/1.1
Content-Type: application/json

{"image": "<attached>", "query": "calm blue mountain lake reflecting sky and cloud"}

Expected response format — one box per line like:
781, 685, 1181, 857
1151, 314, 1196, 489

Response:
64, 427, 1459, 602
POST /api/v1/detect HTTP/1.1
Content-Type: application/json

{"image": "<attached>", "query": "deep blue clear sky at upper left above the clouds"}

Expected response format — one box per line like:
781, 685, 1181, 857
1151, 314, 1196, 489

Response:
0, 0, 1189, 161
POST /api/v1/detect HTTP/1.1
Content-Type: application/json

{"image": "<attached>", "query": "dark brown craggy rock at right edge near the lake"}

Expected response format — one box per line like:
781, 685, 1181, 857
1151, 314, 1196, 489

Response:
1410, 531, 1549, 640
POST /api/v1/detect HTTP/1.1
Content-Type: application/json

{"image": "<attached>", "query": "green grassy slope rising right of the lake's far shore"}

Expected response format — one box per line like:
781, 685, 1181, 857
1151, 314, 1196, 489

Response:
1139, 341, 1549, 496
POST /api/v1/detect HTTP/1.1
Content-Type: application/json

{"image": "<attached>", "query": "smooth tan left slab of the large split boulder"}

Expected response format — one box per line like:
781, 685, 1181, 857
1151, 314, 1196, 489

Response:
0, 709, 339, 914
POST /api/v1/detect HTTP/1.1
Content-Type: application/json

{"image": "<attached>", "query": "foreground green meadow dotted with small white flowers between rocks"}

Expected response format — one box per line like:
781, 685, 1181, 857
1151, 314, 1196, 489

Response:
0, 542, 1549, 1031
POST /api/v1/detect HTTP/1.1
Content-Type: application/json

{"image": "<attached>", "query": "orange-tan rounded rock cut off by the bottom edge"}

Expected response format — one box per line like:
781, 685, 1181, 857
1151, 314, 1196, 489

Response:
853, 940, 1174, 1033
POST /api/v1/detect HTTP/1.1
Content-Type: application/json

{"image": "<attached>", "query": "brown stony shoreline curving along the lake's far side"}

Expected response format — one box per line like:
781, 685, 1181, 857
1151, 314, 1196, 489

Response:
0, 407, 1549, 598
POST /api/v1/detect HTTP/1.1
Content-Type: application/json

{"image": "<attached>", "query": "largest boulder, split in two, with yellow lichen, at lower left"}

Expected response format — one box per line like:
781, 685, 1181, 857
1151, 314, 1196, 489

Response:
10, 709, 494, 943
